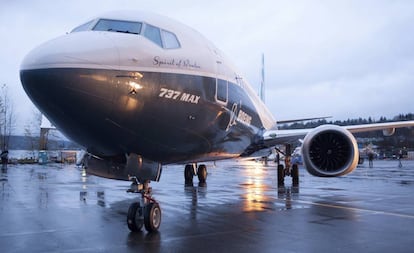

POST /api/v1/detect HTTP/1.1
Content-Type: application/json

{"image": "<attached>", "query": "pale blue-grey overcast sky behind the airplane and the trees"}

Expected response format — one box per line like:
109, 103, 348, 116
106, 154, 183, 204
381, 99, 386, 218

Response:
0, 0, 414, 134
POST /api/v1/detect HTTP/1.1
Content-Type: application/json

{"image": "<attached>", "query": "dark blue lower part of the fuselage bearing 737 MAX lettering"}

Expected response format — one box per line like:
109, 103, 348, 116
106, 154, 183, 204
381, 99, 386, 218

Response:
21, 68, 263, 163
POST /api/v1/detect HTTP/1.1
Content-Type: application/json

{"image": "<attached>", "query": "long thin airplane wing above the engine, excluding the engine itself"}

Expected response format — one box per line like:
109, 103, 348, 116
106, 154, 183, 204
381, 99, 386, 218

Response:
263, 120, 414, 147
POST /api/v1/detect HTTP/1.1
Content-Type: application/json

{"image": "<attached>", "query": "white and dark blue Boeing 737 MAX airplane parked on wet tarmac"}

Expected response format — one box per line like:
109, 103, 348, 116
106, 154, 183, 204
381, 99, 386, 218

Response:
20, 11, 414, 232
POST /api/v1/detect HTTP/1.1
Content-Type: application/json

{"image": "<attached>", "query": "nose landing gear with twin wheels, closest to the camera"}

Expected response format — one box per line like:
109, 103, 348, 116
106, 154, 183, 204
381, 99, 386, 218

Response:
127, 177, 161, 232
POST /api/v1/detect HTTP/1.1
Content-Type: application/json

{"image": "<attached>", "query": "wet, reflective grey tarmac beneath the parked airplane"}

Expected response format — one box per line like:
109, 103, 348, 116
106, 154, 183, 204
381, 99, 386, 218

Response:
0, 161, 414, 252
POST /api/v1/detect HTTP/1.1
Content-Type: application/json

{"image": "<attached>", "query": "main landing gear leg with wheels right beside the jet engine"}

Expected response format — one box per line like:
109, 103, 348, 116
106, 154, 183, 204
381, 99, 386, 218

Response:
276, 143, 299, 186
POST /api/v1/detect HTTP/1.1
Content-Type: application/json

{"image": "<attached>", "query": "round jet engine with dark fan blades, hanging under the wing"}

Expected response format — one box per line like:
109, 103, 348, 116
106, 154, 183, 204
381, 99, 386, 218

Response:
302, 125, 359, 177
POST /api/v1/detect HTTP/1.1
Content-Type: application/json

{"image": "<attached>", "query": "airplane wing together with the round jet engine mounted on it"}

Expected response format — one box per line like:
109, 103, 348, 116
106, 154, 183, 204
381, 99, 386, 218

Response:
260, 121, 414, 177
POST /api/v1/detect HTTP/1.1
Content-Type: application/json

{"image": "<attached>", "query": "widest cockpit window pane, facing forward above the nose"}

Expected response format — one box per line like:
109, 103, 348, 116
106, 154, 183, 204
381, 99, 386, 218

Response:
93, 19, 142, 34
